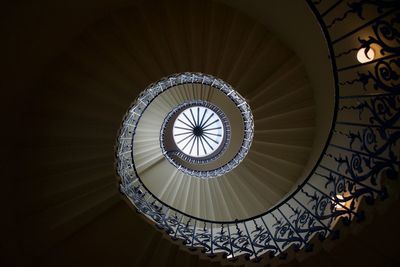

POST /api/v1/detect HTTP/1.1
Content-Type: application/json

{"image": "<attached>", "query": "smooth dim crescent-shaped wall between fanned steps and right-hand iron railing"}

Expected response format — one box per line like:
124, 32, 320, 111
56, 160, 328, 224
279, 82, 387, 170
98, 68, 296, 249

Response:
219, 0, 335, 189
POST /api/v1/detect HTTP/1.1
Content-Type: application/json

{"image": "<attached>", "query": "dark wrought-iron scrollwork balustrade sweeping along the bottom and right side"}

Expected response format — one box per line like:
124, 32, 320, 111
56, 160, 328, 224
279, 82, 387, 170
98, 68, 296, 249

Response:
116, 0, 400, 261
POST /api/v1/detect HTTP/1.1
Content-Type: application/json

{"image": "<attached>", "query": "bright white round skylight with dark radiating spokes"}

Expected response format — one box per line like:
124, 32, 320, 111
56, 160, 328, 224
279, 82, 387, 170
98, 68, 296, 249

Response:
172, 106, 225, 158
